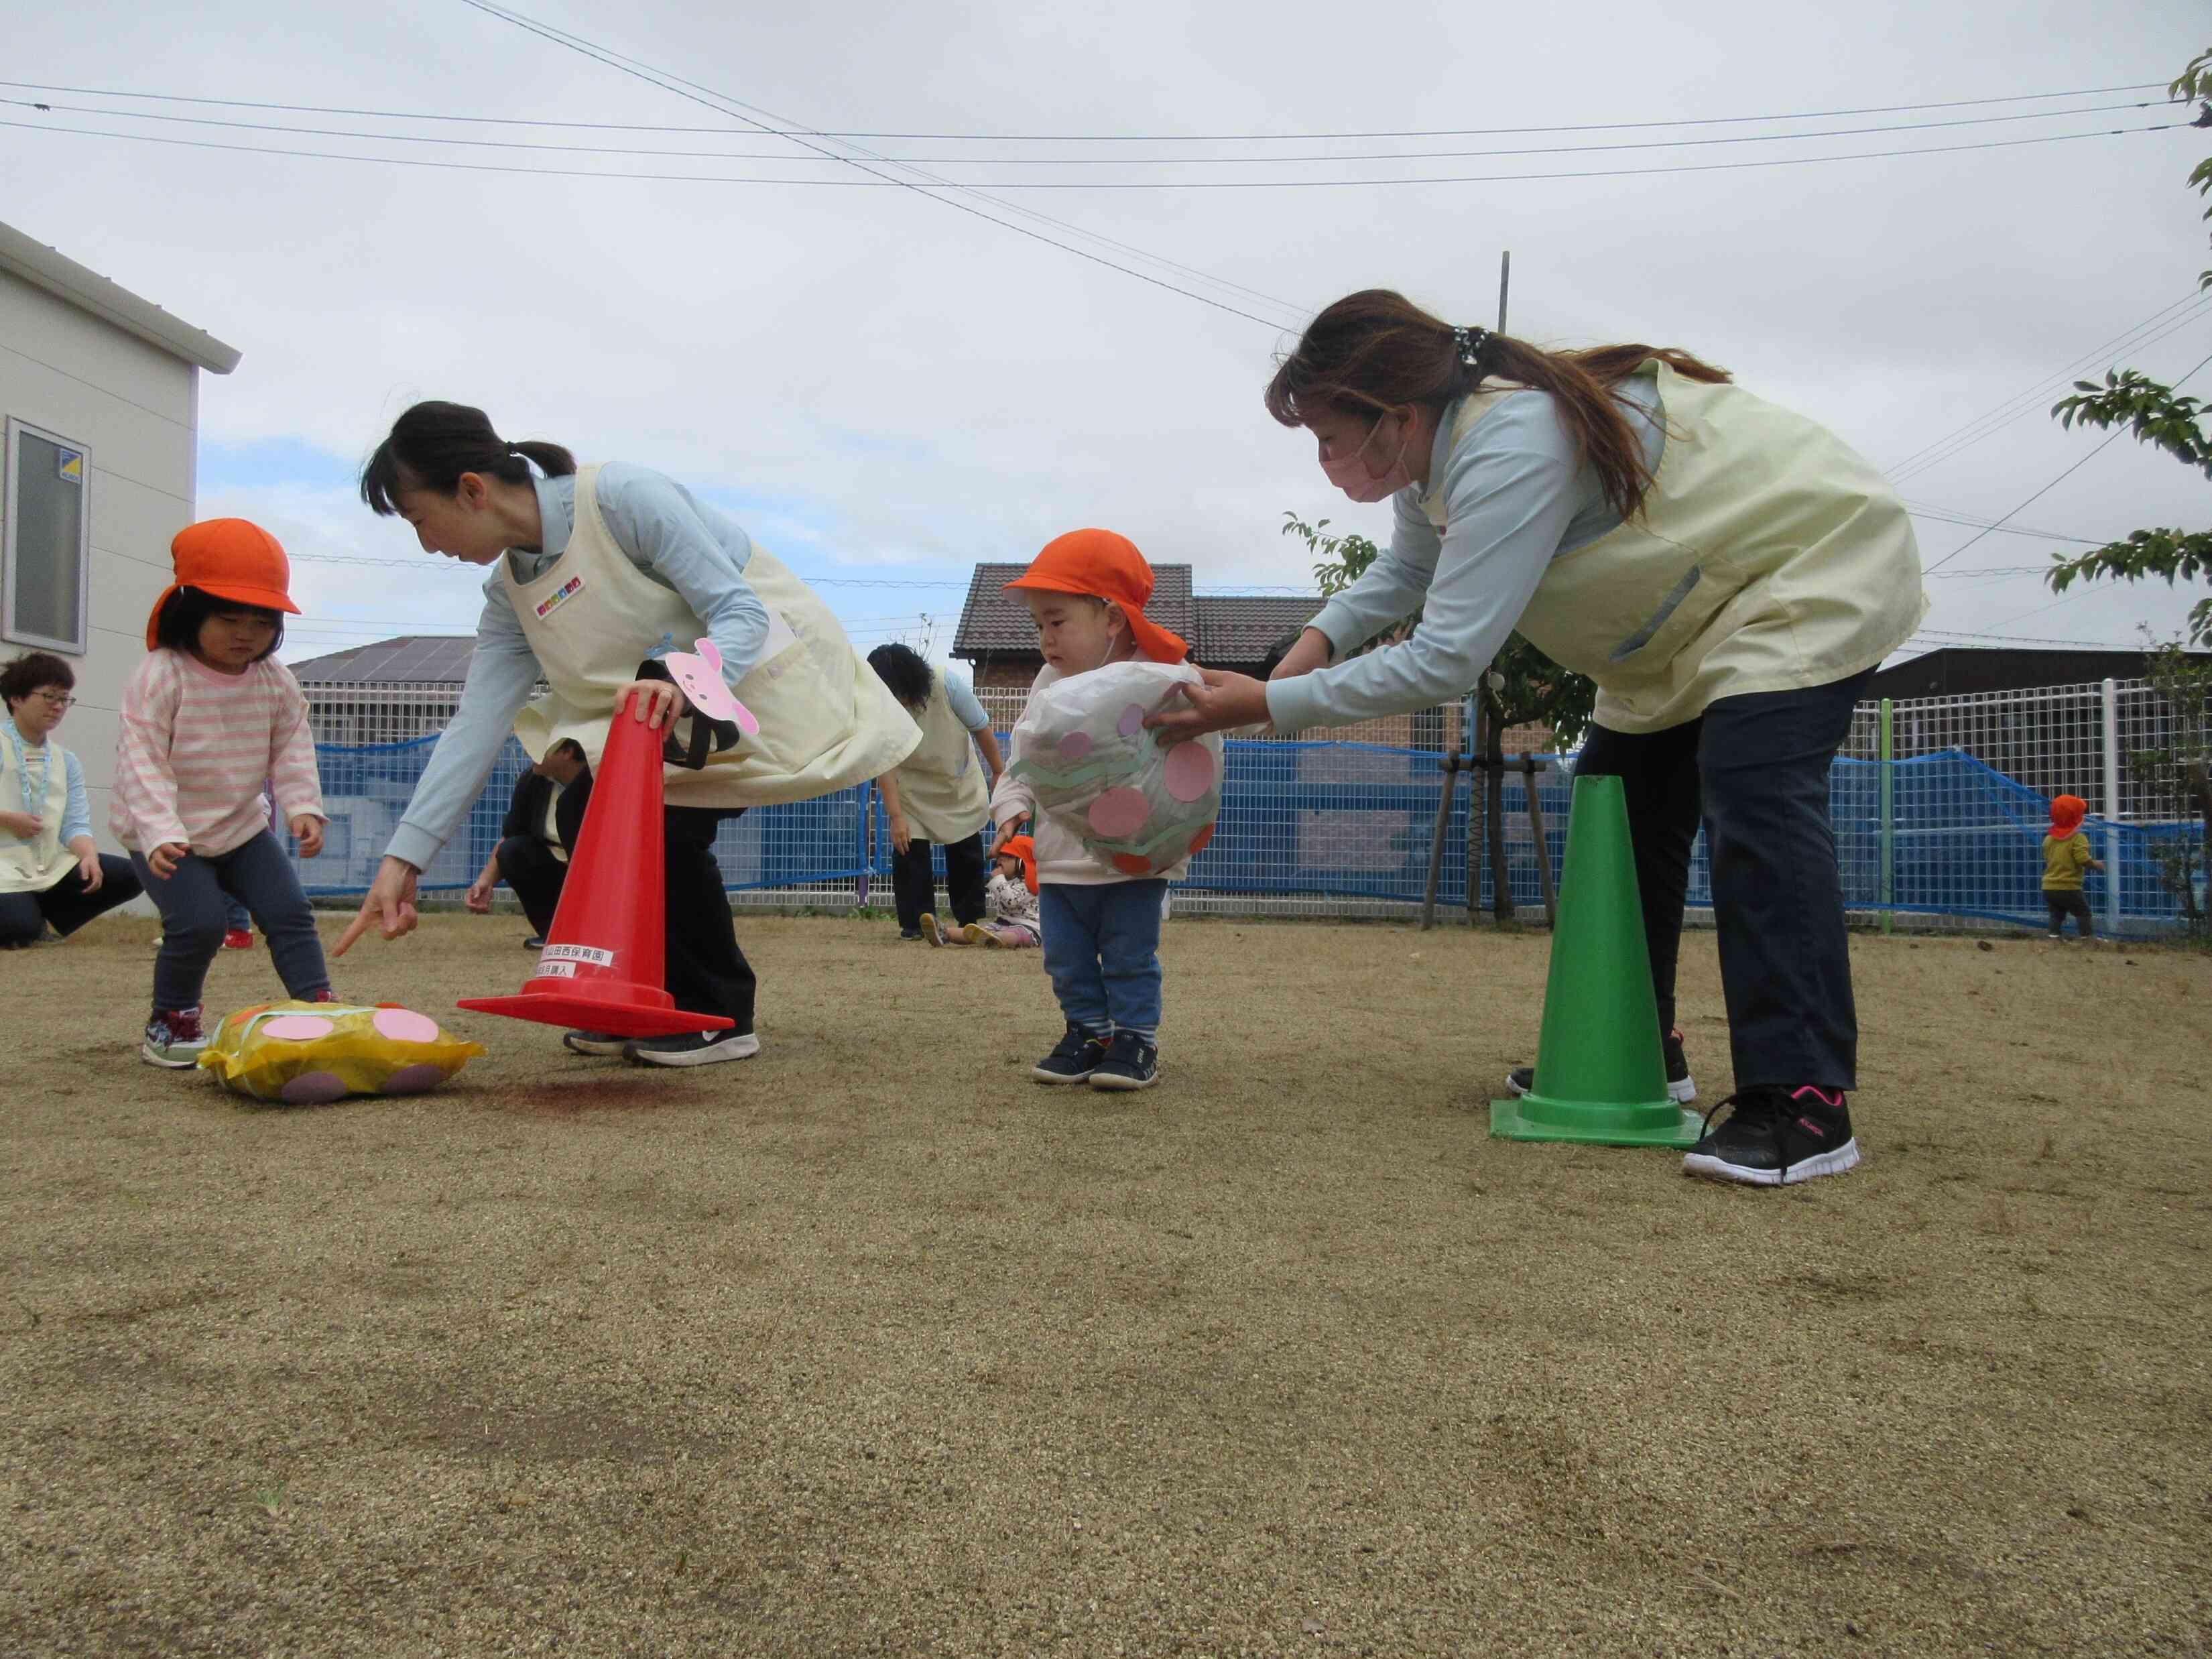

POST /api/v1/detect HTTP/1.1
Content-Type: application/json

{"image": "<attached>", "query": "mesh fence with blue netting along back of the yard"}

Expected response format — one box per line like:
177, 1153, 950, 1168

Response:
301, 681, 2203, 931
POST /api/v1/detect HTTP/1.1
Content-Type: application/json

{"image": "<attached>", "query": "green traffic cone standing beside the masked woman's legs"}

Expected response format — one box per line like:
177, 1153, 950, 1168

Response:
1491, 779, 1703, 1146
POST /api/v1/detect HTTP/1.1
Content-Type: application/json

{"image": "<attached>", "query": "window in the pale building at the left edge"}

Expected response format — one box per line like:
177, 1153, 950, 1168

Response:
0, 420, 93, 657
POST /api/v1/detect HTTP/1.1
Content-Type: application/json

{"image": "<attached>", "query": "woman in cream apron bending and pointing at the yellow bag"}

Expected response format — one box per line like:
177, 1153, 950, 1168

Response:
336, 403, 918, 1066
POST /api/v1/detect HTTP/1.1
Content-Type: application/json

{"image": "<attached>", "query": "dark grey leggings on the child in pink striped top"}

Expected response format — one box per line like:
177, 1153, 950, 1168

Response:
131, 830, 330, 1013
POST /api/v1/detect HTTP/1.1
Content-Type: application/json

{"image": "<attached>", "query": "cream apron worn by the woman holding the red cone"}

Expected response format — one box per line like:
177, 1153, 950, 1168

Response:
500, 467, 920, 808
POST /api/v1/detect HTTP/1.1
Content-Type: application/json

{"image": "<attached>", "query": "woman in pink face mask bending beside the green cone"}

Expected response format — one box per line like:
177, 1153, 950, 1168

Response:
1155, 290, 1926, 1186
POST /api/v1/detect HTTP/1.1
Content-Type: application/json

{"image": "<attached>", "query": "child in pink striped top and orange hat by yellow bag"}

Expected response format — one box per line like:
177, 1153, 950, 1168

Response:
109, 517, 330, 1068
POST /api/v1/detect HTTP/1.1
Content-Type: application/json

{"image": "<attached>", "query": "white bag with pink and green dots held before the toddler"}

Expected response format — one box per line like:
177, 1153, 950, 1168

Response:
1007, 662, 1221, 876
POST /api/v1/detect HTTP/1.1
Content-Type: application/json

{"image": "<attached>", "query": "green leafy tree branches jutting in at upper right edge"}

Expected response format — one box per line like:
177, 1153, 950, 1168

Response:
2044, 51, 2212, 643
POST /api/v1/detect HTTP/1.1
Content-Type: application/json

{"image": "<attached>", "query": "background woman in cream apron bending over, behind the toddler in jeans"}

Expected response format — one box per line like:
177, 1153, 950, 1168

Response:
867, 646, 1007, 944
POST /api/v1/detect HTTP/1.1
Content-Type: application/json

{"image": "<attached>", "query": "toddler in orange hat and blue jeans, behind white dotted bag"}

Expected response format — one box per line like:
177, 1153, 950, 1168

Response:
991, 531, 1188, 1089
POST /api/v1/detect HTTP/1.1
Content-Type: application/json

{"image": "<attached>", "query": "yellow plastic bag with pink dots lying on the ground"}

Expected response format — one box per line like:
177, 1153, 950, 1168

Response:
199, 1002, 485, 1106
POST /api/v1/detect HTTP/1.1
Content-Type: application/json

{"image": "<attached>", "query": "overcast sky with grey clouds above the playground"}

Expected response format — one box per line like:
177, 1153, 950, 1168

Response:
0, 0, 2212, 659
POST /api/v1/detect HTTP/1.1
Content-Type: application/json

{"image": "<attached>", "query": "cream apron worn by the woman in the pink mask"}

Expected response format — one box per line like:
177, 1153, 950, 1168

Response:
1422, 359, 1929, 732
